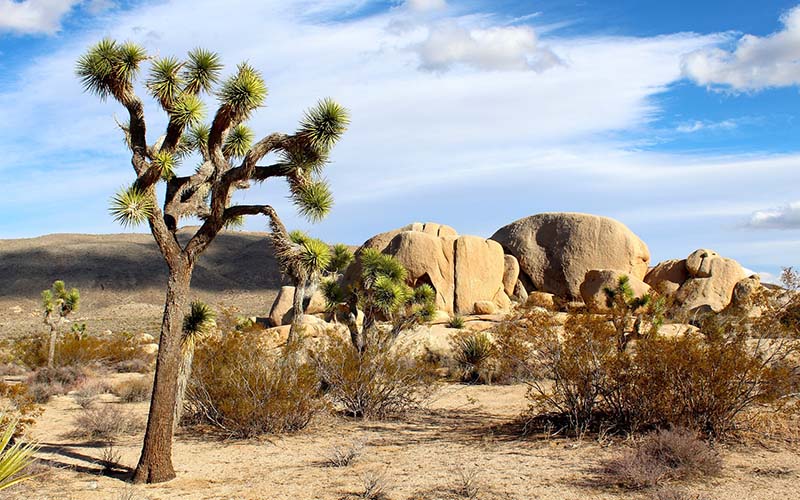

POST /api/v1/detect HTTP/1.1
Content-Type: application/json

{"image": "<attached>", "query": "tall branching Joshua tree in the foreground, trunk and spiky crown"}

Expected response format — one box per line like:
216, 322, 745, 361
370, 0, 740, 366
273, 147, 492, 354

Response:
77, 40, 348, 483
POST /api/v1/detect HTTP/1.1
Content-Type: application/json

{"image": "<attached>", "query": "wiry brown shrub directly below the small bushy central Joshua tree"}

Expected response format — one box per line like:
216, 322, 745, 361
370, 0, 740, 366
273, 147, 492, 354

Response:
315, 334, 434, 419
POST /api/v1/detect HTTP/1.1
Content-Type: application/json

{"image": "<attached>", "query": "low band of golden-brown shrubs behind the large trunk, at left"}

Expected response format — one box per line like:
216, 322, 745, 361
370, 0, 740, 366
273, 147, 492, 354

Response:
12, 331, 153, 369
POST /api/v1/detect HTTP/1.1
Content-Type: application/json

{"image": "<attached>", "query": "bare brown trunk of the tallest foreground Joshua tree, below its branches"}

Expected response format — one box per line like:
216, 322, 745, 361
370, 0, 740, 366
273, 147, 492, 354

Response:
133, 259, 193, 483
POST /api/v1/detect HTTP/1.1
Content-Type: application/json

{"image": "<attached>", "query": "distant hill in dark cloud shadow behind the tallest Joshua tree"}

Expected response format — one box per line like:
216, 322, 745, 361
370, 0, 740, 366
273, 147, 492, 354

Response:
0, 231, 281, 310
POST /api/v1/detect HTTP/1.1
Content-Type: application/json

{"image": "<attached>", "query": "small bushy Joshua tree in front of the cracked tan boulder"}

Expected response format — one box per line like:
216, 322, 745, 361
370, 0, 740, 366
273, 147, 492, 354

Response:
323, 248, 436, 352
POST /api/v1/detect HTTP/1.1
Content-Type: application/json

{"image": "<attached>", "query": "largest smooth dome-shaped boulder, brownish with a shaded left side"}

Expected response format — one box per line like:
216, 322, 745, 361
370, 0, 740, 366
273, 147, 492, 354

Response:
491, 213, 650, 300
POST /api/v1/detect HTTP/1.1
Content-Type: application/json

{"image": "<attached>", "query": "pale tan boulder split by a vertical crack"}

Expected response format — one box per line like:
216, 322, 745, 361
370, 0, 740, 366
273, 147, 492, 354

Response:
345, 222, 516, 314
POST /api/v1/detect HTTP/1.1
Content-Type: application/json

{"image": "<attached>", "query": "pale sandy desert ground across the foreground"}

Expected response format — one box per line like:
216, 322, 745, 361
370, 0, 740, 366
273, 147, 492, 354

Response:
10, 384, 800, 500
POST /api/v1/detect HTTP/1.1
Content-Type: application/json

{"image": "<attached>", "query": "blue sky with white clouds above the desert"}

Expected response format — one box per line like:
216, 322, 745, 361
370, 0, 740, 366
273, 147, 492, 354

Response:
0, 0, 800, 279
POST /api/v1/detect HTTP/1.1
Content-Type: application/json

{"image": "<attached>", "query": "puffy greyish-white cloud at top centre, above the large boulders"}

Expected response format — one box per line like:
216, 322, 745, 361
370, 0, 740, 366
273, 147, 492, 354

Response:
417, 23, 561, 71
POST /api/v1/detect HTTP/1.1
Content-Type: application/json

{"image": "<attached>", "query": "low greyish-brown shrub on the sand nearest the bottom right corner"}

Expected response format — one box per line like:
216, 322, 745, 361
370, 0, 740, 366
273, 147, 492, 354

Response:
602, 430, 722, 489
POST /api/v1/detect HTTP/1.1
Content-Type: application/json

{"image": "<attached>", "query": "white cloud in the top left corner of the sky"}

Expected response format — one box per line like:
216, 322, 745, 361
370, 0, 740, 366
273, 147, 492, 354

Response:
0, 0, 80, 34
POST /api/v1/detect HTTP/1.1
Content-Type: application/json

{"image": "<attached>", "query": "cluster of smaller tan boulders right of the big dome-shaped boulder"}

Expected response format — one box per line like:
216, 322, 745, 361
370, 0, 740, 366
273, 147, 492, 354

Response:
645, 248, 746, 312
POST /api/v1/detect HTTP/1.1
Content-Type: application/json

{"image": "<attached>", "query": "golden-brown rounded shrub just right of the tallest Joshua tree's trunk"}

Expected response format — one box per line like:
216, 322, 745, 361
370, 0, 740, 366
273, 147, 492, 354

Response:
184, 331, 324, 438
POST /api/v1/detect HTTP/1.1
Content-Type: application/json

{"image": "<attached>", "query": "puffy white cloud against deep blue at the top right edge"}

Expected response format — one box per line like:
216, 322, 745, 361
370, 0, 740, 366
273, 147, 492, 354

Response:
683, 6, 800, 91
